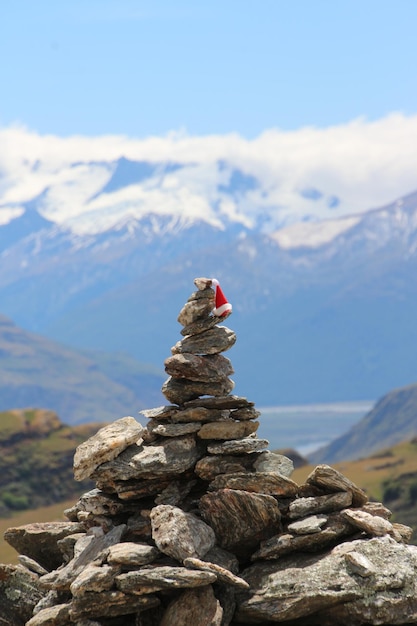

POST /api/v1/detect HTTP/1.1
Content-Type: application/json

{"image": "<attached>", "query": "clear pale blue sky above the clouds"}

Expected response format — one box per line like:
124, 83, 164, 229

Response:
0, 0, 417, 139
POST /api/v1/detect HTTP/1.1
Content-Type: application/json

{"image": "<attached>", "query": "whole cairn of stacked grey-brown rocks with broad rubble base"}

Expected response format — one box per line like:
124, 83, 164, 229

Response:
0, 278, 417, 626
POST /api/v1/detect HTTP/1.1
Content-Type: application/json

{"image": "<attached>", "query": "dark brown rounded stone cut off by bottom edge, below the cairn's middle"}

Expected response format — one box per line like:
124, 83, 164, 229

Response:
160, 586, 224, 626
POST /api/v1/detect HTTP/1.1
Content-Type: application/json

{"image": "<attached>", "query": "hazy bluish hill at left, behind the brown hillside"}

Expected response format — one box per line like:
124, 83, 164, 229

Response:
0, 315, 166, 424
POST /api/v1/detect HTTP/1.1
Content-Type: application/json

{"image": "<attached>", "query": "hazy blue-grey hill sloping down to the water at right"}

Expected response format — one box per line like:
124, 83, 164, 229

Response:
309, 383, 417, 463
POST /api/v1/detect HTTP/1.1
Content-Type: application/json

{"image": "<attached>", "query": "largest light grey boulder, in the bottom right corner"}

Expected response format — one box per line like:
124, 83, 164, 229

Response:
237, 537, 417, 626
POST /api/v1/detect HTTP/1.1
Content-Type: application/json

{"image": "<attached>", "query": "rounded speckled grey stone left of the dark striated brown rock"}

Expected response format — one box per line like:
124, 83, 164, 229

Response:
151, 504, 216, 562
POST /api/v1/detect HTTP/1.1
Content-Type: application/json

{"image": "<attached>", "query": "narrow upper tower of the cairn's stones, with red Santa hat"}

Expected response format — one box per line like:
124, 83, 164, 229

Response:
162, 278, 236, 406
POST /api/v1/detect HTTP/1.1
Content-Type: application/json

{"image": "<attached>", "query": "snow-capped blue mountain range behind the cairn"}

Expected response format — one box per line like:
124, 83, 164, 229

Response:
0, 150, 417, 404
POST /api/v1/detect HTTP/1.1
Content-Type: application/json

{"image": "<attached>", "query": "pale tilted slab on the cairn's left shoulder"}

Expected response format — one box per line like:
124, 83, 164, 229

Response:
74, 417, 143, 480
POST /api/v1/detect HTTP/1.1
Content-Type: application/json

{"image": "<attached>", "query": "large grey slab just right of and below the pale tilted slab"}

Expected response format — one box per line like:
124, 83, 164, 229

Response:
93, 435, 200, 483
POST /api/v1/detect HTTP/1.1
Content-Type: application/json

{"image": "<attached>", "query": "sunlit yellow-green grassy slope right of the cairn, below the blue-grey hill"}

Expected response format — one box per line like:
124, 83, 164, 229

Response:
292, 438, 417, 543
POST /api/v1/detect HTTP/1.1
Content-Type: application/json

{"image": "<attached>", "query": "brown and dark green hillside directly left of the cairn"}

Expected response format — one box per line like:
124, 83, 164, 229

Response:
0, 409, 102, 517
